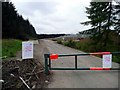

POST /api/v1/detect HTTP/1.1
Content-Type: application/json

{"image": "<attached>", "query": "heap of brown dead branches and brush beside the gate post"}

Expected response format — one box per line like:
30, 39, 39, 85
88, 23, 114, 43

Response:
2, 59, 50, 90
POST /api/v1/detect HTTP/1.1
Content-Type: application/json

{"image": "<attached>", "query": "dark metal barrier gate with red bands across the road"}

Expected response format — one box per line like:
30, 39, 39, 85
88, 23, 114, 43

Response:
44, 52, 120, 75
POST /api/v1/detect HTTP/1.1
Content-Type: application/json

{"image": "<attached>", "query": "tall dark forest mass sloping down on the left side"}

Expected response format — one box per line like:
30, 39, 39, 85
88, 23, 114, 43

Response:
2, 2, 37, 40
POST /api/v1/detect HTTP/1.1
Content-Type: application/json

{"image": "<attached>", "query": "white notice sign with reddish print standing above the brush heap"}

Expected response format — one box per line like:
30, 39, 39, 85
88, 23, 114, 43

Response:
22, 41, 33, 59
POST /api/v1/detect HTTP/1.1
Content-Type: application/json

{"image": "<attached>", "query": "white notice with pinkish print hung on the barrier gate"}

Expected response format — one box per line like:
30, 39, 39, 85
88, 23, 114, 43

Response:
103, 54, 112, 68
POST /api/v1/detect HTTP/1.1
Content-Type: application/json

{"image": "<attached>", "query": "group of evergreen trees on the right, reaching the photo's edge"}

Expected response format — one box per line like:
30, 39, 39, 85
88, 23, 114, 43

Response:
79, 0, 120, 47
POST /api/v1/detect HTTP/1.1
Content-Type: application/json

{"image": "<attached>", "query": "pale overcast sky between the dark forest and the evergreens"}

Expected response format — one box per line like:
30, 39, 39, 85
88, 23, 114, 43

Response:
12, 0, 90, 34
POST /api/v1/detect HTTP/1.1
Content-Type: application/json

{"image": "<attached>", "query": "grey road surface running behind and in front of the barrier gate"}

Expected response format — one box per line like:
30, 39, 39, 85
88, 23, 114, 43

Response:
38, 40, 119, 88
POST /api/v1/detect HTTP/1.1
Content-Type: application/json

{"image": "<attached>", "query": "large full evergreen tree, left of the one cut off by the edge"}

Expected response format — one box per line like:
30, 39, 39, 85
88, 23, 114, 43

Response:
81, 2, 114, 46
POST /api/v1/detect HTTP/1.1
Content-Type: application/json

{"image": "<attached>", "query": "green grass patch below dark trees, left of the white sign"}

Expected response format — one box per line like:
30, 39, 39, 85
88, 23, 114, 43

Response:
2, 39, 22, 57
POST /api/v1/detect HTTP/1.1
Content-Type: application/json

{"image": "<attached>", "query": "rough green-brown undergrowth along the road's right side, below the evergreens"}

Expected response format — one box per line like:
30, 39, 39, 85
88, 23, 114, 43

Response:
57, 31, 120, 63
